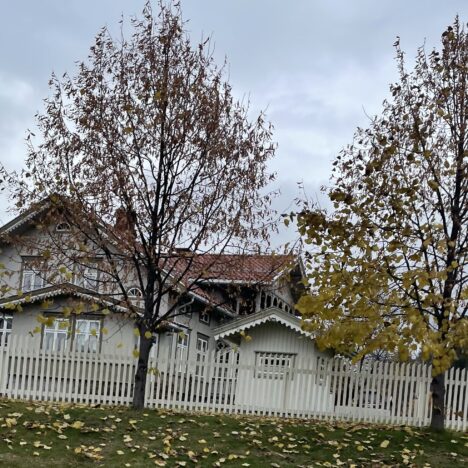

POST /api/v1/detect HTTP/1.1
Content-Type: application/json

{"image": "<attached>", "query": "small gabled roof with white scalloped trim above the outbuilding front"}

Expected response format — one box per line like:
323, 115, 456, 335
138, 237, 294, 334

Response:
214, 307, 312, 340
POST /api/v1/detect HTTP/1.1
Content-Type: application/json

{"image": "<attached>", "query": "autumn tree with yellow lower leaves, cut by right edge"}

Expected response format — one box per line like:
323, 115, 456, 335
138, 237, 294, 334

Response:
297, 18, 468, 428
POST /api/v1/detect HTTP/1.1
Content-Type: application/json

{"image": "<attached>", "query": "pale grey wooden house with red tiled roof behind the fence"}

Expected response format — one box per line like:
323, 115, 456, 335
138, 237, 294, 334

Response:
0, 199, 330, 378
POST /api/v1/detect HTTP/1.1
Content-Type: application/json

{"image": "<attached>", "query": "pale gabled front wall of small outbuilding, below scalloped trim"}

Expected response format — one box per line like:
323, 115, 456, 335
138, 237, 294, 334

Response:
236, 322, 334, 411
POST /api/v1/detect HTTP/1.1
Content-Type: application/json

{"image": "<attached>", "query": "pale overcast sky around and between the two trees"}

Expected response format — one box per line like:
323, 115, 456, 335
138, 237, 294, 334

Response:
0, 0, 468, 247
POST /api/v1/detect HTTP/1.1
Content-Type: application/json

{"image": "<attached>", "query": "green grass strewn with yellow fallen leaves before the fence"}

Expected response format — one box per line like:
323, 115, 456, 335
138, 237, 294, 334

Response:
0, 400, 468, 468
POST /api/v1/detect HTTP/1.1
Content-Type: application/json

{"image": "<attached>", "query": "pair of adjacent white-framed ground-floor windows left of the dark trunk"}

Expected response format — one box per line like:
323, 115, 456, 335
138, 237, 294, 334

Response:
43, 317, 101, 352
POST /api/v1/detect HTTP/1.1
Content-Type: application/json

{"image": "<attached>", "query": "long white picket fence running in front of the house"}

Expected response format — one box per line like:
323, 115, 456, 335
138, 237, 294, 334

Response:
0, 336, 468, 431
